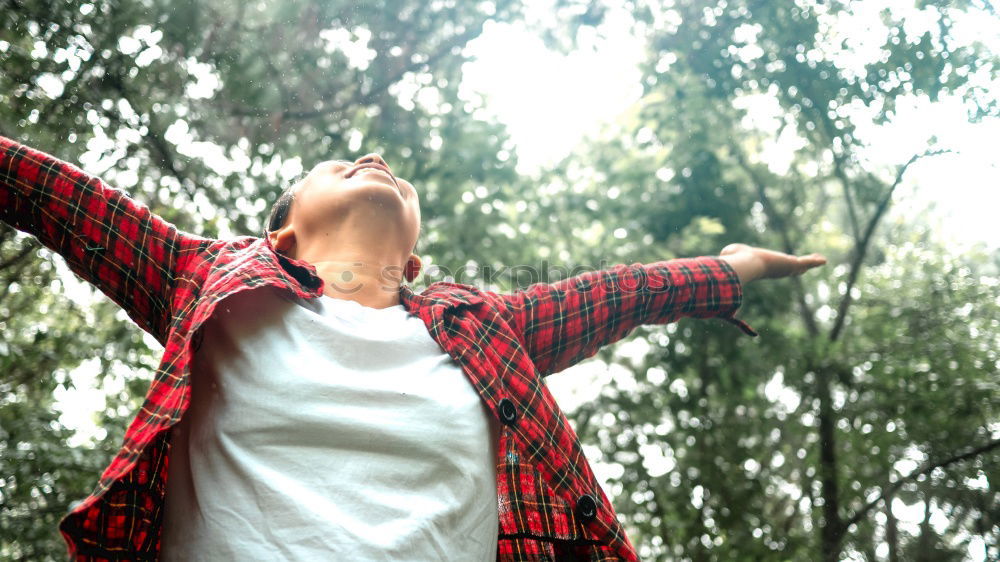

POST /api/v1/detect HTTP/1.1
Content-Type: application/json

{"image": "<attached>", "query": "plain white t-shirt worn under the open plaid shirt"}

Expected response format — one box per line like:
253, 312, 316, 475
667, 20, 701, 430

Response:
161, 287, 498, 561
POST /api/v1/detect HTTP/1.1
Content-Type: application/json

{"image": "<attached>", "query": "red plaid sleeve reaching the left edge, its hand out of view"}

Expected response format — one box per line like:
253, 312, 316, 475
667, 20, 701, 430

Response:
0, 136, 205, 343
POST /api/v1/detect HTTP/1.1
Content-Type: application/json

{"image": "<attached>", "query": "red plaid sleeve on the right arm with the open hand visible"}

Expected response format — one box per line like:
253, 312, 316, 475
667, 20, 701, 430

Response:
498, 257, 757, 376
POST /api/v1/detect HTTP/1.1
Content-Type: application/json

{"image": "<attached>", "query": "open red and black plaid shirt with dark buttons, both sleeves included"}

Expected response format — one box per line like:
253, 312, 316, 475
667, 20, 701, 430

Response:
0, 137, 753, 560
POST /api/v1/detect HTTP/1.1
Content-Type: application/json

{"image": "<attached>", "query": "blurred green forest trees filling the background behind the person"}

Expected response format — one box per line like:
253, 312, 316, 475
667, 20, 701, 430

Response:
0, 0, 1000, 561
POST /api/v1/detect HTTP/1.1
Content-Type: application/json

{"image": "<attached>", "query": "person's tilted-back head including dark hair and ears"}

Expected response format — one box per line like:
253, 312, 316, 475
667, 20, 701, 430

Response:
265, 154, 420, 281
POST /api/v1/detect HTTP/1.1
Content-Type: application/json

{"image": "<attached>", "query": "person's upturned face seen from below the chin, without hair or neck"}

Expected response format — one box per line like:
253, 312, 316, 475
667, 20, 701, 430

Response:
288, 154, 420, 251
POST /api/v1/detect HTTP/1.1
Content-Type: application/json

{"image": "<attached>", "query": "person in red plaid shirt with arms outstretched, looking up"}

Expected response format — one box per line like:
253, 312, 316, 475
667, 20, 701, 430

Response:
0, 137, 825, 560
